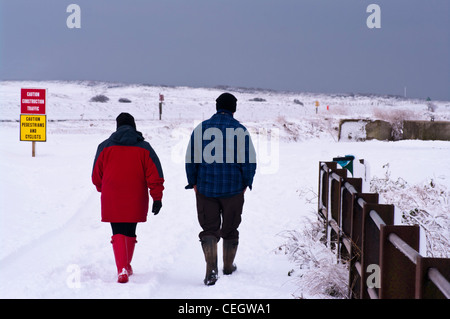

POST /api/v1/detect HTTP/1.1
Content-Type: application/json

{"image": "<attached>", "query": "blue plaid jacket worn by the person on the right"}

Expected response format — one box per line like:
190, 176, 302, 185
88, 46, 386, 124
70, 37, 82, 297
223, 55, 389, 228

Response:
185, 110, 256, 197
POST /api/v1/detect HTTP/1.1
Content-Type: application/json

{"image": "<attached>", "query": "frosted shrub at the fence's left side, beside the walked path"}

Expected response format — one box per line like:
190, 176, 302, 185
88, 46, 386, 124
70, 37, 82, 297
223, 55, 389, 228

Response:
279, 221, 348, 298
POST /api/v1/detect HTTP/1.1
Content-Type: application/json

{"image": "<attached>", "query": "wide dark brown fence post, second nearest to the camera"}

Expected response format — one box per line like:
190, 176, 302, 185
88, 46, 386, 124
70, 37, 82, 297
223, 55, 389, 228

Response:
379, 225, 419, 299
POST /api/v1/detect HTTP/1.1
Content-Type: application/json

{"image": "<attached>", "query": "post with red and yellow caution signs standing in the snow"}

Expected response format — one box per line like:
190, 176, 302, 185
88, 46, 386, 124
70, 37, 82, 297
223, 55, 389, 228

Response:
20, 89, 47, 157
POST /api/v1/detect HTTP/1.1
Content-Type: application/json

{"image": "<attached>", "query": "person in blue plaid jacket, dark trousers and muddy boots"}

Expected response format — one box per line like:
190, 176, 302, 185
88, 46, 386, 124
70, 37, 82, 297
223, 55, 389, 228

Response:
186, 93, 256, 285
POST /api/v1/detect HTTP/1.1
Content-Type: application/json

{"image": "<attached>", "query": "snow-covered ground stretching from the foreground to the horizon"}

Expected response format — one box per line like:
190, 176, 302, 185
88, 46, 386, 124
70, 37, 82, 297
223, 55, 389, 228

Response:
0, 82, 450, 299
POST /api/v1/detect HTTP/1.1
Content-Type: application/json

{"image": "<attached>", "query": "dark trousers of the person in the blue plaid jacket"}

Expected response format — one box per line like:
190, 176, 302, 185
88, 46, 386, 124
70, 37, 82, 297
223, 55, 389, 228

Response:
196, 192, 244, 240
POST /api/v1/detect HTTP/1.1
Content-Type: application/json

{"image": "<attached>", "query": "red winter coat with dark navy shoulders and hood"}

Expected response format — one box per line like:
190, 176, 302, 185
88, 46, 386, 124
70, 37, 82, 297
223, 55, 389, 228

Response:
92, 125, 164, 223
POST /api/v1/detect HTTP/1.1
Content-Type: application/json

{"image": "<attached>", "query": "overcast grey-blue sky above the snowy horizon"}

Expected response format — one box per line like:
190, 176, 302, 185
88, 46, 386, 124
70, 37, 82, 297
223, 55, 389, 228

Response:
0, 0, 450, 100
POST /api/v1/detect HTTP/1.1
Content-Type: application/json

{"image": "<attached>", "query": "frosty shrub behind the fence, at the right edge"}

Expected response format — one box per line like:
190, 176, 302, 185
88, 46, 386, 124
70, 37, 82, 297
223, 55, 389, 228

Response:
370, 163, 450, 258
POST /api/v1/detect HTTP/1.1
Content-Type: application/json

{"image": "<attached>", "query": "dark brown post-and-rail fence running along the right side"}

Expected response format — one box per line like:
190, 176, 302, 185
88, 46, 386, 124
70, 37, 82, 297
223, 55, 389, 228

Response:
318, 162, 450, 299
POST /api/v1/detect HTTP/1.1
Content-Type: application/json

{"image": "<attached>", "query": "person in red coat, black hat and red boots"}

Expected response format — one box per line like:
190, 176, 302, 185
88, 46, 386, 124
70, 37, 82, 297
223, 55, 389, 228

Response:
92, 113, 164, 283
